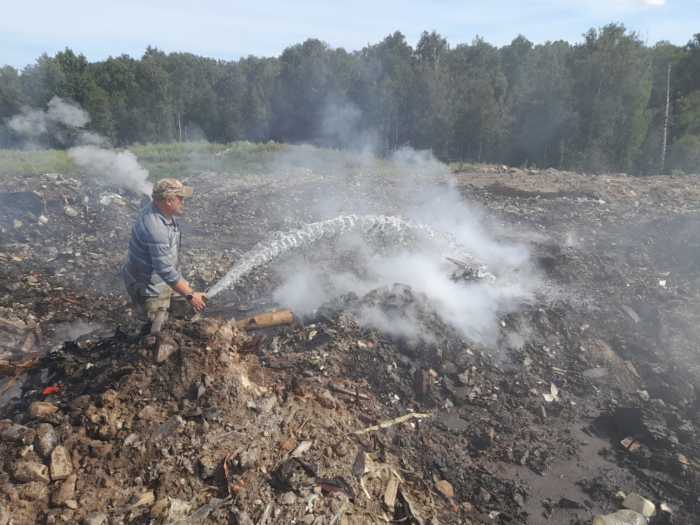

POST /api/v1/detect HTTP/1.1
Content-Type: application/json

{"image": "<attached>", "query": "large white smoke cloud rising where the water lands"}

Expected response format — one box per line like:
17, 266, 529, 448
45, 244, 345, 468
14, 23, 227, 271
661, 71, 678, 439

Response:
262, 145, 542, 344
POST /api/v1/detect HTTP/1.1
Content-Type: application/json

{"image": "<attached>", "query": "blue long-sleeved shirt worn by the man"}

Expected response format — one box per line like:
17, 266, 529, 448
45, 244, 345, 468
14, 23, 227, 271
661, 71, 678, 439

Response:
122, 203, 182, 296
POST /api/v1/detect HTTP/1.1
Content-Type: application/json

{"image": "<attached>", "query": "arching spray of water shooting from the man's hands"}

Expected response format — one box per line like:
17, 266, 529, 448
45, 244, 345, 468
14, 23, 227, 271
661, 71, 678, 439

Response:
207, 215, 492, 298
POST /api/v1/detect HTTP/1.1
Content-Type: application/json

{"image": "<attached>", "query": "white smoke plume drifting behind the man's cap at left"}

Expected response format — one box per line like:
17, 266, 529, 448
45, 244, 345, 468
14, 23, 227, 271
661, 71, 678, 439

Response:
8, 96, 153, 195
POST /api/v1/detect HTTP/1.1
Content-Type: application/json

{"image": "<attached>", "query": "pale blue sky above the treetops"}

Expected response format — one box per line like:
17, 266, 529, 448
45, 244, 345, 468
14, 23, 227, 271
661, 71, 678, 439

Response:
0, 0, 700, 68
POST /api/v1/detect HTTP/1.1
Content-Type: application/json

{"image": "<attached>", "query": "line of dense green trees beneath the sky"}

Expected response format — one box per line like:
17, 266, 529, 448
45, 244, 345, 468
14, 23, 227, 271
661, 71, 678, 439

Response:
0, 24, 700, 174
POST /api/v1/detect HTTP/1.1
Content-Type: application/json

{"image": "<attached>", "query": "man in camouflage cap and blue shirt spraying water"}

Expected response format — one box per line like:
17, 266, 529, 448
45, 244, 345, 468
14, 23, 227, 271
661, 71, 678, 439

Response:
122, 179, 206, 332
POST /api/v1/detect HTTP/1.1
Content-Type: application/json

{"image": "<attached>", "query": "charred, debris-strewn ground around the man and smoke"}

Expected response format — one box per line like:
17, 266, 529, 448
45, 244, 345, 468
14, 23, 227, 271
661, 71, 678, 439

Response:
0, 148, 700, 524
